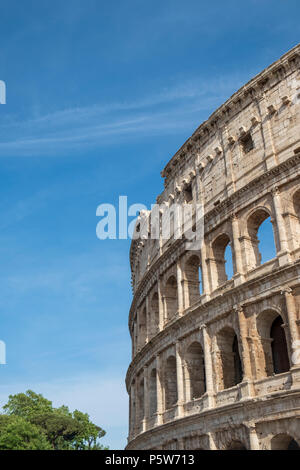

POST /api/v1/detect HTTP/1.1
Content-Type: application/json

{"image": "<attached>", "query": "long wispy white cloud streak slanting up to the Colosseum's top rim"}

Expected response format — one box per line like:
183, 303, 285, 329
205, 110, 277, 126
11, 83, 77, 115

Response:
0, 72, 243, 156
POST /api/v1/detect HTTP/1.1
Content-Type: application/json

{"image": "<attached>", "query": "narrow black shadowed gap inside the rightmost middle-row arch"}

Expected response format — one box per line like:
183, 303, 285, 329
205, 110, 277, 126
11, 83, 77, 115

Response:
271, 315, 290, 374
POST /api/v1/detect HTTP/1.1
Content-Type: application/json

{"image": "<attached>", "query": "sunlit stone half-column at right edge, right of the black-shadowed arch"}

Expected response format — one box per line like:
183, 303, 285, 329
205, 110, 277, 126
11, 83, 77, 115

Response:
281, 287, 300, 367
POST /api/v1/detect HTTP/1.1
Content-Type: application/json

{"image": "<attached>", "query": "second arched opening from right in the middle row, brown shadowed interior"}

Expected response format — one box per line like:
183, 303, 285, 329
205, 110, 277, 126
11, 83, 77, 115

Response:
217, 327, 243, 390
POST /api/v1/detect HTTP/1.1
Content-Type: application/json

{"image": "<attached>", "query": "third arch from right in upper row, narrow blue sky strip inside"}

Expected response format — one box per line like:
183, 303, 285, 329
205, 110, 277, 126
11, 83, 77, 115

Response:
211, 233, 234, 289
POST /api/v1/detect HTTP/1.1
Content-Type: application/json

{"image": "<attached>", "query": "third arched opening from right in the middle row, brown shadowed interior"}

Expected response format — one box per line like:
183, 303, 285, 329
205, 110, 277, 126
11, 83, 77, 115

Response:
185, 342, 206, 400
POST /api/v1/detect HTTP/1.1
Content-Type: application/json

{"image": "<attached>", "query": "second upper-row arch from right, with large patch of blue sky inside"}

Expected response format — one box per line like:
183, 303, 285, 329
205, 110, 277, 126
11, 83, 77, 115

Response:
245, 209, 276, 269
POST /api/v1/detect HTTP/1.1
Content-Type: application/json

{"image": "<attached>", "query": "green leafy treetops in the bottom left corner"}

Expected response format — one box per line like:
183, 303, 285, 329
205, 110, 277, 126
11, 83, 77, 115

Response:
0, 390, 105, 450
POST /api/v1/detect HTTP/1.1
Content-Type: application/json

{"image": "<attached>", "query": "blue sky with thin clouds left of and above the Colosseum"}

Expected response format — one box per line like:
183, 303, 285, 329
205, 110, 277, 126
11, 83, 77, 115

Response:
0, 0, 300, 448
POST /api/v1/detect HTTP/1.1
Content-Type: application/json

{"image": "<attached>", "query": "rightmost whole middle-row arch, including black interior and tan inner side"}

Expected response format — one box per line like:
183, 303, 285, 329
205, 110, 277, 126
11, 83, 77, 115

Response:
257, 309, 290, 376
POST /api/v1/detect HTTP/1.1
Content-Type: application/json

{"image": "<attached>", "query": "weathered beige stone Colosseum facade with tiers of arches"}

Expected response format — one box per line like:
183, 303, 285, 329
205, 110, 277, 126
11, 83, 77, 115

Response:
126, 45, 300, 450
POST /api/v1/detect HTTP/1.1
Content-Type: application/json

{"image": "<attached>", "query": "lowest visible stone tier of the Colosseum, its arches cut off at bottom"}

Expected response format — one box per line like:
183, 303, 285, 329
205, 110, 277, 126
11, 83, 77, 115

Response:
126, 389, 300, 450
